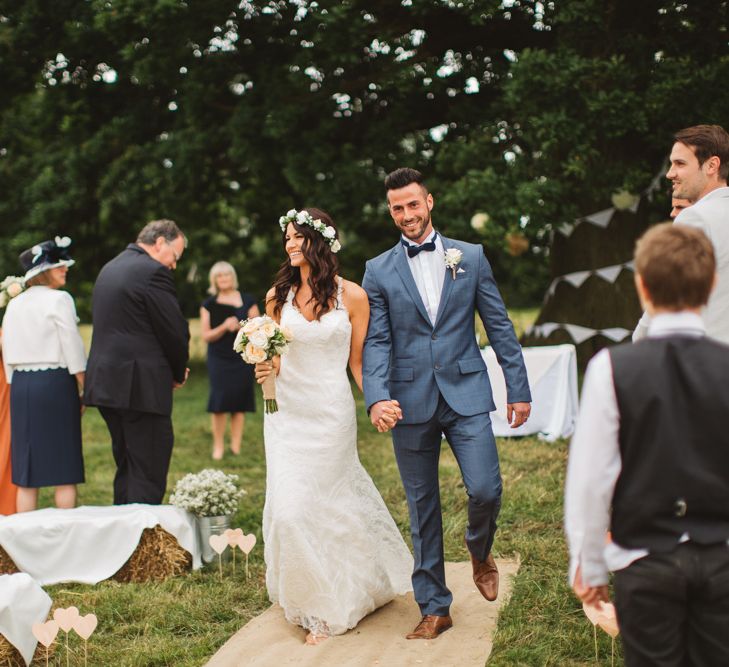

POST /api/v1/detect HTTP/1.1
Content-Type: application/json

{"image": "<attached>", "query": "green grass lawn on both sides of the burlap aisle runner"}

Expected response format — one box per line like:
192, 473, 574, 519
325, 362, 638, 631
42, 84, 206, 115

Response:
25, 317, 621, 667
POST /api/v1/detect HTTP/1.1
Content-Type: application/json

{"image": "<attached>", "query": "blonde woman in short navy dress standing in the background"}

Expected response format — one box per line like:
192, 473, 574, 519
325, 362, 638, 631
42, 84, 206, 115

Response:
200, 262, 260, 461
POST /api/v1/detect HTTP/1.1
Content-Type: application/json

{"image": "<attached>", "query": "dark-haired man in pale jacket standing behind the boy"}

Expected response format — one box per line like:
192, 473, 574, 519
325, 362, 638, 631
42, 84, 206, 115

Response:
633, 125, 729, 343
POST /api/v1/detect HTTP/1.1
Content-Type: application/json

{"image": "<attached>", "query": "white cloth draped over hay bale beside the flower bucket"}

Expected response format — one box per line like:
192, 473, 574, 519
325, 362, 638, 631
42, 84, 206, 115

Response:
0, 504, 202, 586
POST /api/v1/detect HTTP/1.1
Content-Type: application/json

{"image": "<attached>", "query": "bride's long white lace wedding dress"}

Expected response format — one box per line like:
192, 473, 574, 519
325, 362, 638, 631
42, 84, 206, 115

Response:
263, 279, 413, 635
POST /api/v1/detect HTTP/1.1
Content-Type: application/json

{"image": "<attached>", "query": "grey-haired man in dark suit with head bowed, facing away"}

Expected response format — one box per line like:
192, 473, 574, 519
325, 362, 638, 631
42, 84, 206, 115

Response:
84, 220, 190, 505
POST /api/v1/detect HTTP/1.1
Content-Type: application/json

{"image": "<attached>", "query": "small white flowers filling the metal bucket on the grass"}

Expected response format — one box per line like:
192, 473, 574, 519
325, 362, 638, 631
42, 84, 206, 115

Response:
170, 468, 246, 516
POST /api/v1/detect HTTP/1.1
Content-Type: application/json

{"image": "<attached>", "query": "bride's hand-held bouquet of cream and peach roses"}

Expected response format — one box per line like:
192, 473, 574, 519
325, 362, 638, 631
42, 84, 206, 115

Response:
233, 315, 293, 413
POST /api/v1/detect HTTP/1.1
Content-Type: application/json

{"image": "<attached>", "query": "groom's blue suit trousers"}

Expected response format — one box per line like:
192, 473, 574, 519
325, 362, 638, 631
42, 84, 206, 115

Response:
392, 396, 501, 616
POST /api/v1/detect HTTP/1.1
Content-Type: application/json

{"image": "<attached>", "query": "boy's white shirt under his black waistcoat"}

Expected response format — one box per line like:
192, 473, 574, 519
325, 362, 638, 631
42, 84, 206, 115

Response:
565, 312, 706, 586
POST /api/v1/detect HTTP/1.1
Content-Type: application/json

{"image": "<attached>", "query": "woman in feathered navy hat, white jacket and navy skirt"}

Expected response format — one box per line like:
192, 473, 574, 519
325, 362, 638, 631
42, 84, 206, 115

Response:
2, 236, 86, 512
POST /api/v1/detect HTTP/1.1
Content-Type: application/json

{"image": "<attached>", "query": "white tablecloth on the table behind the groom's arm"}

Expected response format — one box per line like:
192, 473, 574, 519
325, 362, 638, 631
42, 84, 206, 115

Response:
481, 345, 578, 441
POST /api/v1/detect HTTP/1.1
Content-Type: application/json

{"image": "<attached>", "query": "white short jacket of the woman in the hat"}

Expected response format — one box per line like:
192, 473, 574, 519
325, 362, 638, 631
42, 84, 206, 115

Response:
2, 285, 86, 384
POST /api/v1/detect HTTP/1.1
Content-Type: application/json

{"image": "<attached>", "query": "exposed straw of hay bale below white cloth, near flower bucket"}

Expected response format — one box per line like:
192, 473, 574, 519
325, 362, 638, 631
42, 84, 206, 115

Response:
111, 526, 192, 580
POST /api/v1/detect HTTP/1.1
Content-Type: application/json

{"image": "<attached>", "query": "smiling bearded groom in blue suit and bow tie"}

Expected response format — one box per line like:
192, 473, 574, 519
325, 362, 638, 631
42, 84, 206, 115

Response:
362, 168, 531, 639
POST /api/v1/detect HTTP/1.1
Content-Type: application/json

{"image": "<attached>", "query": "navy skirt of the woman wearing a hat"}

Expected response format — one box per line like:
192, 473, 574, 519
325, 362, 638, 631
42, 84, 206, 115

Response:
10, 368, 84, 488
